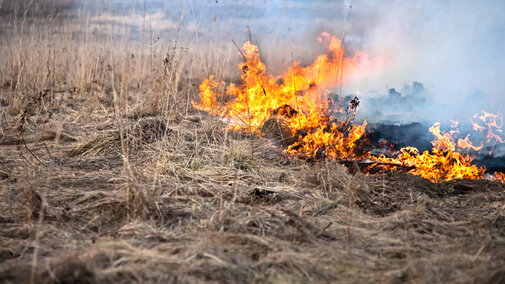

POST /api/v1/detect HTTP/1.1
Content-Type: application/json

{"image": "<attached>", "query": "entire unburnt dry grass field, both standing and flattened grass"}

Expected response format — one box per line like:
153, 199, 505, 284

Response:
0, 1, 505, 283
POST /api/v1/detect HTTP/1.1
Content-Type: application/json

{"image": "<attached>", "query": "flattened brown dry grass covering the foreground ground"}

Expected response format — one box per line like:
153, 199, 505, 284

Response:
0, 88, 505, 283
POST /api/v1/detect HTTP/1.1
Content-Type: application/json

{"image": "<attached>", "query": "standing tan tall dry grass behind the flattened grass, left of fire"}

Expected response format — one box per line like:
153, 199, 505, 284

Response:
0, 3, 197, 114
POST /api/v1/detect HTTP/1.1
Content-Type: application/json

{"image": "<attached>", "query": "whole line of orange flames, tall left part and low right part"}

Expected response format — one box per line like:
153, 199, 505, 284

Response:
193, 33, 505, 182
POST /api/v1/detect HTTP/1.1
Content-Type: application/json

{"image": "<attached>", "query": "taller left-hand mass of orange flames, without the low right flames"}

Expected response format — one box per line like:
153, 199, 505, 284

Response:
193, 33, 374, 158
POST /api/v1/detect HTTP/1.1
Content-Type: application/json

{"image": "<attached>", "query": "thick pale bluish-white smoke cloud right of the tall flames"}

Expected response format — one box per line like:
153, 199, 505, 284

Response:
350, 0, 505, 119
